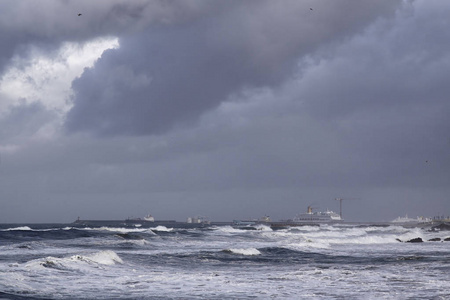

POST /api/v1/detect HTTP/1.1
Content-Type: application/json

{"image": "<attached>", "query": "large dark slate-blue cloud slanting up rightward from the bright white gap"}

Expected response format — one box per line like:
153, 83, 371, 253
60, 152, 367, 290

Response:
66, 1, 399, 135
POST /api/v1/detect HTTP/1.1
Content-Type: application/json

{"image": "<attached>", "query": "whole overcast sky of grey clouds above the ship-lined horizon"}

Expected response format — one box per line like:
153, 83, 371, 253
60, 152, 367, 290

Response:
0, 0, 450, 223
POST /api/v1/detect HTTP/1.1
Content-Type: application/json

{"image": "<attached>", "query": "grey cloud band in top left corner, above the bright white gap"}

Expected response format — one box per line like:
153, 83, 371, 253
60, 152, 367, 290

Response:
0, 0, 209, 71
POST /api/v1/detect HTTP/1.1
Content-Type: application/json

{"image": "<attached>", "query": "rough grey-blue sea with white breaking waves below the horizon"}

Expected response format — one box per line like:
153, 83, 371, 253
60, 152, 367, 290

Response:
0, 222, 450, 299
